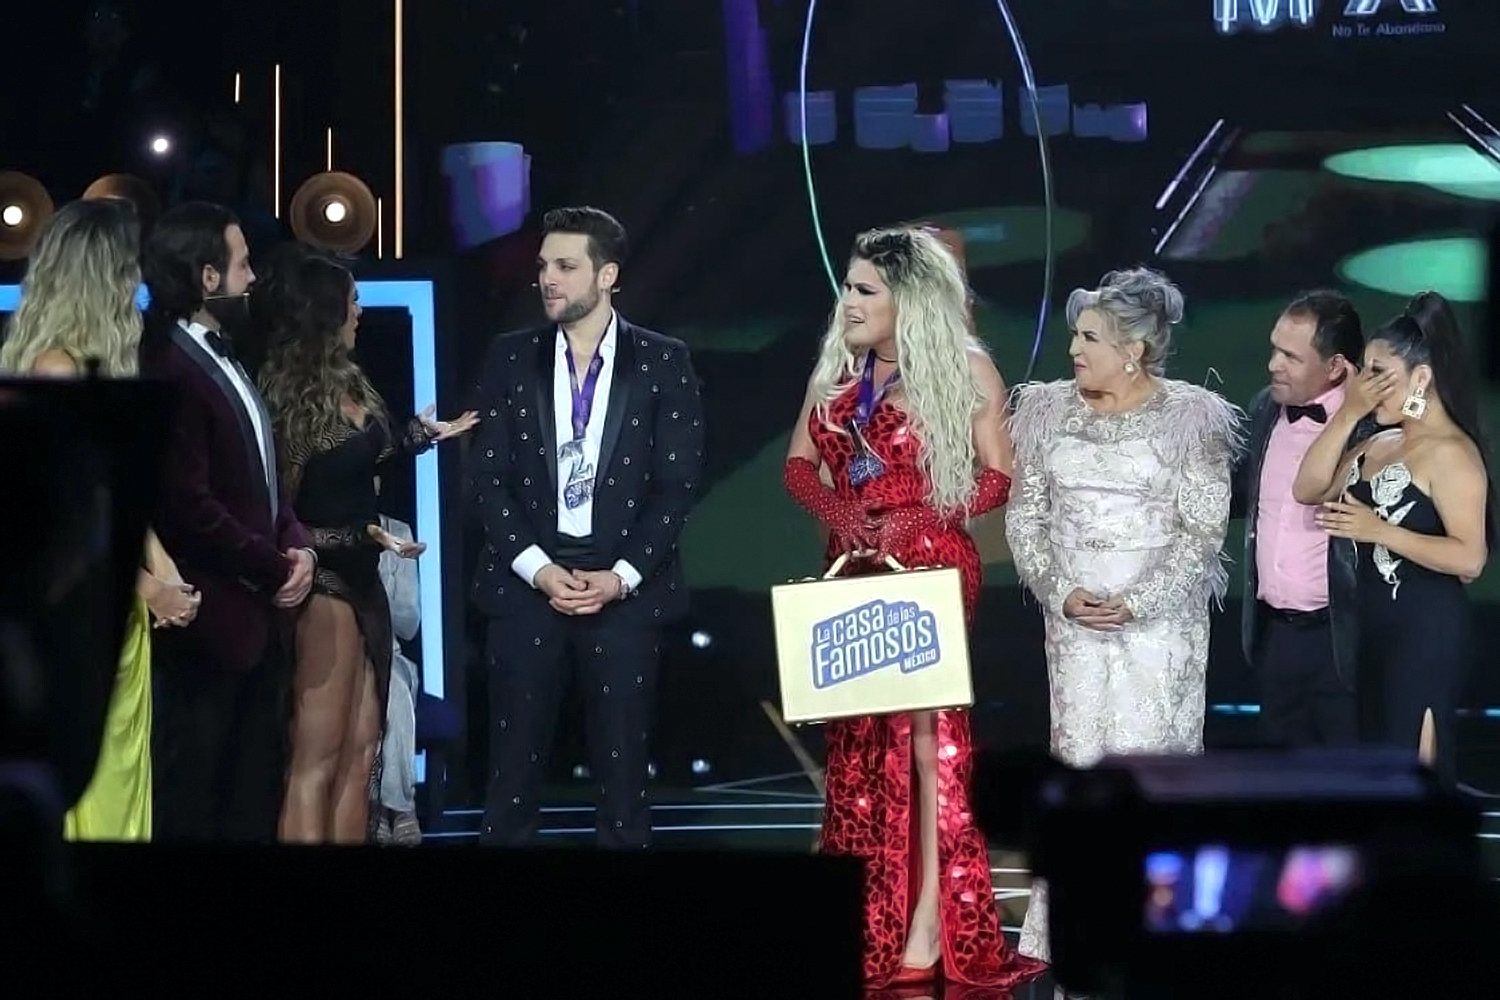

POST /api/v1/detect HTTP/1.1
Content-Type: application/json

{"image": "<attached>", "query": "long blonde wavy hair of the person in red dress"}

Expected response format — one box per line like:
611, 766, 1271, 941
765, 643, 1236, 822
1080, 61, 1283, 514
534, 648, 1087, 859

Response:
813, 228, 984, 513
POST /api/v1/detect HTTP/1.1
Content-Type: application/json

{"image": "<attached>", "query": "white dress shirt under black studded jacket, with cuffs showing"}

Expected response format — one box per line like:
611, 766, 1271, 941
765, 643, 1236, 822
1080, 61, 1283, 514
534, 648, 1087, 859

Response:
510, 312, 641, 592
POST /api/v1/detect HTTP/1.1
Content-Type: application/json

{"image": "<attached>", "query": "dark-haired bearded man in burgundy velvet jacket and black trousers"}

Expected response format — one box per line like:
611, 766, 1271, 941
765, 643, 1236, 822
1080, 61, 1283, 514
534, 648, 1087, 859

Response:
141, 202, 317, 843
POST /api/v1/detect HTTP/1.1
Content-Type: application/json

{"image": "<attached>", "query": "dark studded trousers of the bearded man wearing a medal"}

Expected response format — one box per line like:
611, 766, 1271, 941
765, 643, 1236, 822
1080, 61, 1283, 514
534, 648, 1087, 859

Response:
480, 604, 662, 849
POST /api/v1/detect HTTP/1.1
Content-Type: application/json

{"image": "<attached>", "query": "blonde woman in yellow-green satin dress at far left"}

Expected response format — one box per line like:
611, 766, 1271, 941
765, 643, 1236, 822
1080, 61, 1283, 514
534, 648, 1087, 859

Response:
0, 199, 200, 841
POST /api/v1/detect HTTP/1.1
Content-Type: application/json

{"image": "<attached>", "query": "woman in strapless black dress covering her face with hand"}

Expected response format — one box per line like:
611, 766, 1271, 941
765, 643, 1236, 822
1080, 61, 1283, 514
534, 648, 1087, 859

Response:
1293, 292, 1494, 783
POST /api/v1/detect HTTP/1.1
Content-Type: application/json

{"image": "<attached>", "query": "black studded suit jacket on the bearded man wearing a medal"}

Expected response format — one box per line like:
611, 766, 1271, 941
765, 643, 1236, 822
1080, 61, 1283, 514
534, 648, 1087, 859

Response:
471, 316, 704, 622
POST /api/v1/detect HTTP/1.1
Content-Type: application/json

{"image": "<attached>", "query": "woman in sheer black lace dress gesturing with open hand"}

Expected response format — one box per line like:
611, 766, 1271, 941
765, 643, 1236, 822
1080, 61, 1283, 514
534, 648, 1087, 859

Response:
255, 247, 477, 844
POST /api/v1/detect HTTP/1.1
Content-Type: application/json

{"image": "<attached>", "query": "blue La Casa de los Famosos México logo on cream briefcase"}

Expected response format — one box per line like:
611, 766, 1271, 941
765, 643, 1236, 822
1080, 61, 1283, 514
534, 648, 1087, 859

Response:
812, 601, 942, 691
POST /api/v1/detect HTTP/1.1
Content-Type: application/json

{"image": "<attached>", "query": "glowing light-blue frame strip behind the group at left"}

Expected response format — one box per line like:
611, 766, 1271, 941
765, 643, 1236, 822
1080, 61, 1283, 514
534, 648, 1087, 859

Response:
0, 279, 446, 699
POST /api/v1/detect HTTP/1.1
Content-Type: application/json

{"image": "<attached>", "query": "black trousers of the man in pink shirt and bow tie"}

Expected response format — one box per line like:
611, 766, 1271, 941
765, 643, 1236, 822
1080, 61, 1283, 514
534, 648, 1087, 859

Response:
1256, 606, 1359, 748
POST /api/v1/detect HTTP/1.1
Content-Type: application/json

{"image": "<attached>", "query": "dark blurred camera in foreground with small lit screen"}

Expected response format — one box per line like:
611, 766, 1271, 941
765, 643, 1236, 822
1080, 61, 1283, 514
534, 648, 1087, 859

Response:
975, 751, 1488, 997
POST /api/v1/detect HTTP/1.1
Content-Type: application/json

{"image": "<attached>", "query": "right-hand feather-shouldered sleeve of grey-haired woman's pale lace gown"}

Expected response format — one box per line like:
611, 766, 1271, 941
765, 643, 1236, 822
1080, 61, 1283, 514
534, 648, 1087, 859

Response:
1121, 382, 1244, 622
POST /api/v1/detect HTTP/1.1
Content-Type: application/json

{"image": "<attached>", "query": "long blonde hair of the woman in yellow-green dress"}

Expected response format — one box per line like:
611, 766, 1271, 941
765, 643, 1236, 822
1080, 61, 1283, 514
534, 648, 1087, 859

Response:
0, 198, 141, 378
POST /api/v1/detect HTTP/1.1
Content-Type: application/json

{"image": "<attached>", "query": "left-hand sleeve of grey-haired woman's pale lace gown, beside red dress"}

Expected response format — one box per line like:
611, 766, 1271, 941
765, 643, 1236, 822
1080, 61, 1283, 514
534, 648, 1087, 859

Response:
1005, 382, 1073, 615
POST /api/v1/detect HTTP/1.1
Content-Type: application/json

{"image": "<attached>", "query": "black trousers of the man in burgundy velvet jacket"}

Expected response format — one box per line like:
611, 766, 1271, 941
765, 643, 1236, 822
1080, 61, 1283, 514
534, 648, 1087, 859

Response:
152, 630, 290, 844
